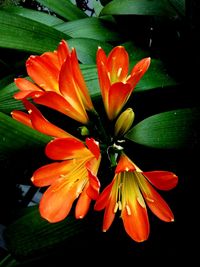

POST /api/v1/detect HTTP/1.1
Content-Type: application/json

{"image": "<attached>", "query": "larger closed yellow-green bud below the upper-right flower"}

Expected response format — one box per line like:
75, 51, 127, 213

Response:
115, 108, 135, 136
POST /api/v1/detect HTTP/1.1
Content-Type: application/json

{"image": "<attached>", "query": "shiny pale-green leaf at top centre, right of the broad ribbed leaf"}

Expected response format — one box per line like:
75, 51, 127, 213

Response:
55, 18, 119, 42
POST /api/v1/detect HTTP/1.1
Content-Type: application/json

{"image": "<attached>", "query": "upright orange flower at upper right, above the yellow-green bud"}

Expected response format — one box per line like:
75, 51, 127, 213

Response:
97, 46, 150, 120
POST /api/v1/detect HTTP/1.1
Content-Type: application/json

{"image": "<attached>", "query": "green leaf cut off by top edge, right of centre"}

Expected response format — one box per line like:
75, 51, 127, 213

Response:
100, 0, 176, 17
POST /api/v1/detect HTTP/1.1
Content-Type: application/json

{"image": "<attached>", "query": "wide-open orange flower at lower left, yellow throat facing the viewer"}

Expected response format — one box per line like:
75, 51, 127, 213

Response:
31, 138, 101, 222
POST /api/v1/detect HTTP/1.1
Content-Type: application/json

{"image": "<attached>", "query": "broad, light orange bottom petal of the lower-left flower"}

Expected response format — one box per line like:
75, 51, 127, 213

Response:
39, 178, 77, 223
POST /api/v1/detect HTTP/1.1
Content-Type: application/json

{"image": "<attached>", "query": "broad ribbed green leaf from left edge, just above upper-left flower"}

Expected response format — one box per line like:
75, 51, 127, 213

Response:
0, 11, 69, 53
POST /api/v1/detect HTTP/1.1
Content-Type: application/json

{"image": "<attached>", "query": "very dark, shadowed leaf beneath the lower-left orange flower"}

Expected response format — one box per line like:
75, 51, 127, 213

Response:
5, 206, 89, 261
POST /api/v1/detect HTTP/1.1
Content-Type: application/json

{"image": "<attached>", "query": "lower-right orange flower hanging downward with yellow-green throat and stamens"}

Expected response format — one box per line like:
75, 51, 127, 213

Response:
94, 154, 178, 242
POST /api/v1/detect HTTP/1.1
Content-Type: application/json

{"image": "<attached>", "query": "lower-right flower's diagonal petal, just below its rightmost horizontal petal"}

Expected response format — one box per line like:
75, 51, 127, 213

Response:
141, 181, 174, 222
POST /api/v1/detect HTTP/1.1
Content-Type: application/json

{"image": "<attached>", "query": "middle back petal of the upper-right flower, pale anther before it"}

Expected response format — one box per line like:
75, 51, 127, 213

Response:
107, 46, 129, 83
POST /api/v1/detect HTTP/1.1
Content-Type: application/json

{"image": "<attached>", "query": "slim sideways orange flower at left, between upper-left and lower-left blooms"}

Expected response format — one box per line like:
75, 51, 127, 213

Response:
11, 99, 72, 138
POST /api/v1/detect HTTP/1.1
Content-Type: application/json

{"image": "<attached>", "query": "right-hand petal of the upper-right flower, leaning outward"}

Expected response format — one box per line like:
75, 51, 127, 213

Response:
127, 57, 151, 89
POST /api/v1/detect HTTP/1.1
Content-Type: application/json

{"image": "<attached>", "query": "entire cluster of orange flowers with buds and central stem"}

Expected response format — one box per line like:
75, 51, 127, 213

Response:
12, 40, 178, 242
